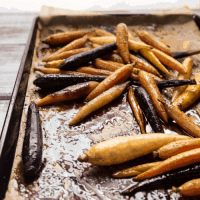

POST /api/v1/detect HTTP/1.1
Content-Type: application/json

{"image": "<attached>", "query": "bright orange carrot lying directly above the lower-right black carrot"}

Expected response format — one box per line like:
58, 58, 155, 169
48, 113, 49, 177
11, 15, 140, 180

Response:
134, 148, 200, 181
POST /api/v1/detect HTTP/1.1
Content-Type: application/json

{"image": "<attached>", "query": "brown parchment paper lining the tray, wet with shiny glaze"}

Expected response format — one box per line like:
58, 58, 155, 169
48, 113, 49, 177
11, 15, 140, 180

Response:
5, 9, 200, 200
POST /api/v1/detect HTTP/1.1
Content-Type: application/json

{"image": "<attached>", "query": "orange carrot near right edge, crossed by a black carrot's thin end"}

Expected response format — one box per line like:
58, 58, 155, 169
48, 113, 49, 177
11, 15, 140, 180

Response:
172, 57, 193, 102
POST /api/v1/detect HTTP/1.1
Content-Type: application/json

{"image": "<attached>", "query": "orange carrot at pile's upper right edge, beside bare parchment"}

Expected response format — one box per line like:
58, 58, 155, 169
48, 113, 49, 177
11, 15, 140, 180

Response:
136, 31, 173, 56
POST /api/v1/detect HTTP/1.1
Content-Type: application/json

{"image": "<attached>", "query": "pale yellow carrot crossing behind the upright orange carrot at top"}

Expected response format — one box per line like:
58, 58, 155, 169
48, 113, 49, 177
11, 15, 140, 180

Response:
89, 36, 151, 51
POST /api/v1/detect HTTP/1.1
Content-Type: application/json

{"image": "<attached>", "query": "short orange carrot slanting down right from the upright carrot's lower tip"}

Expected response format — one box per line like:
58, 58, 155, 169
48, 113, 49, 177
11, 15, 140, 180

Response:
130, 54, 160, 76
